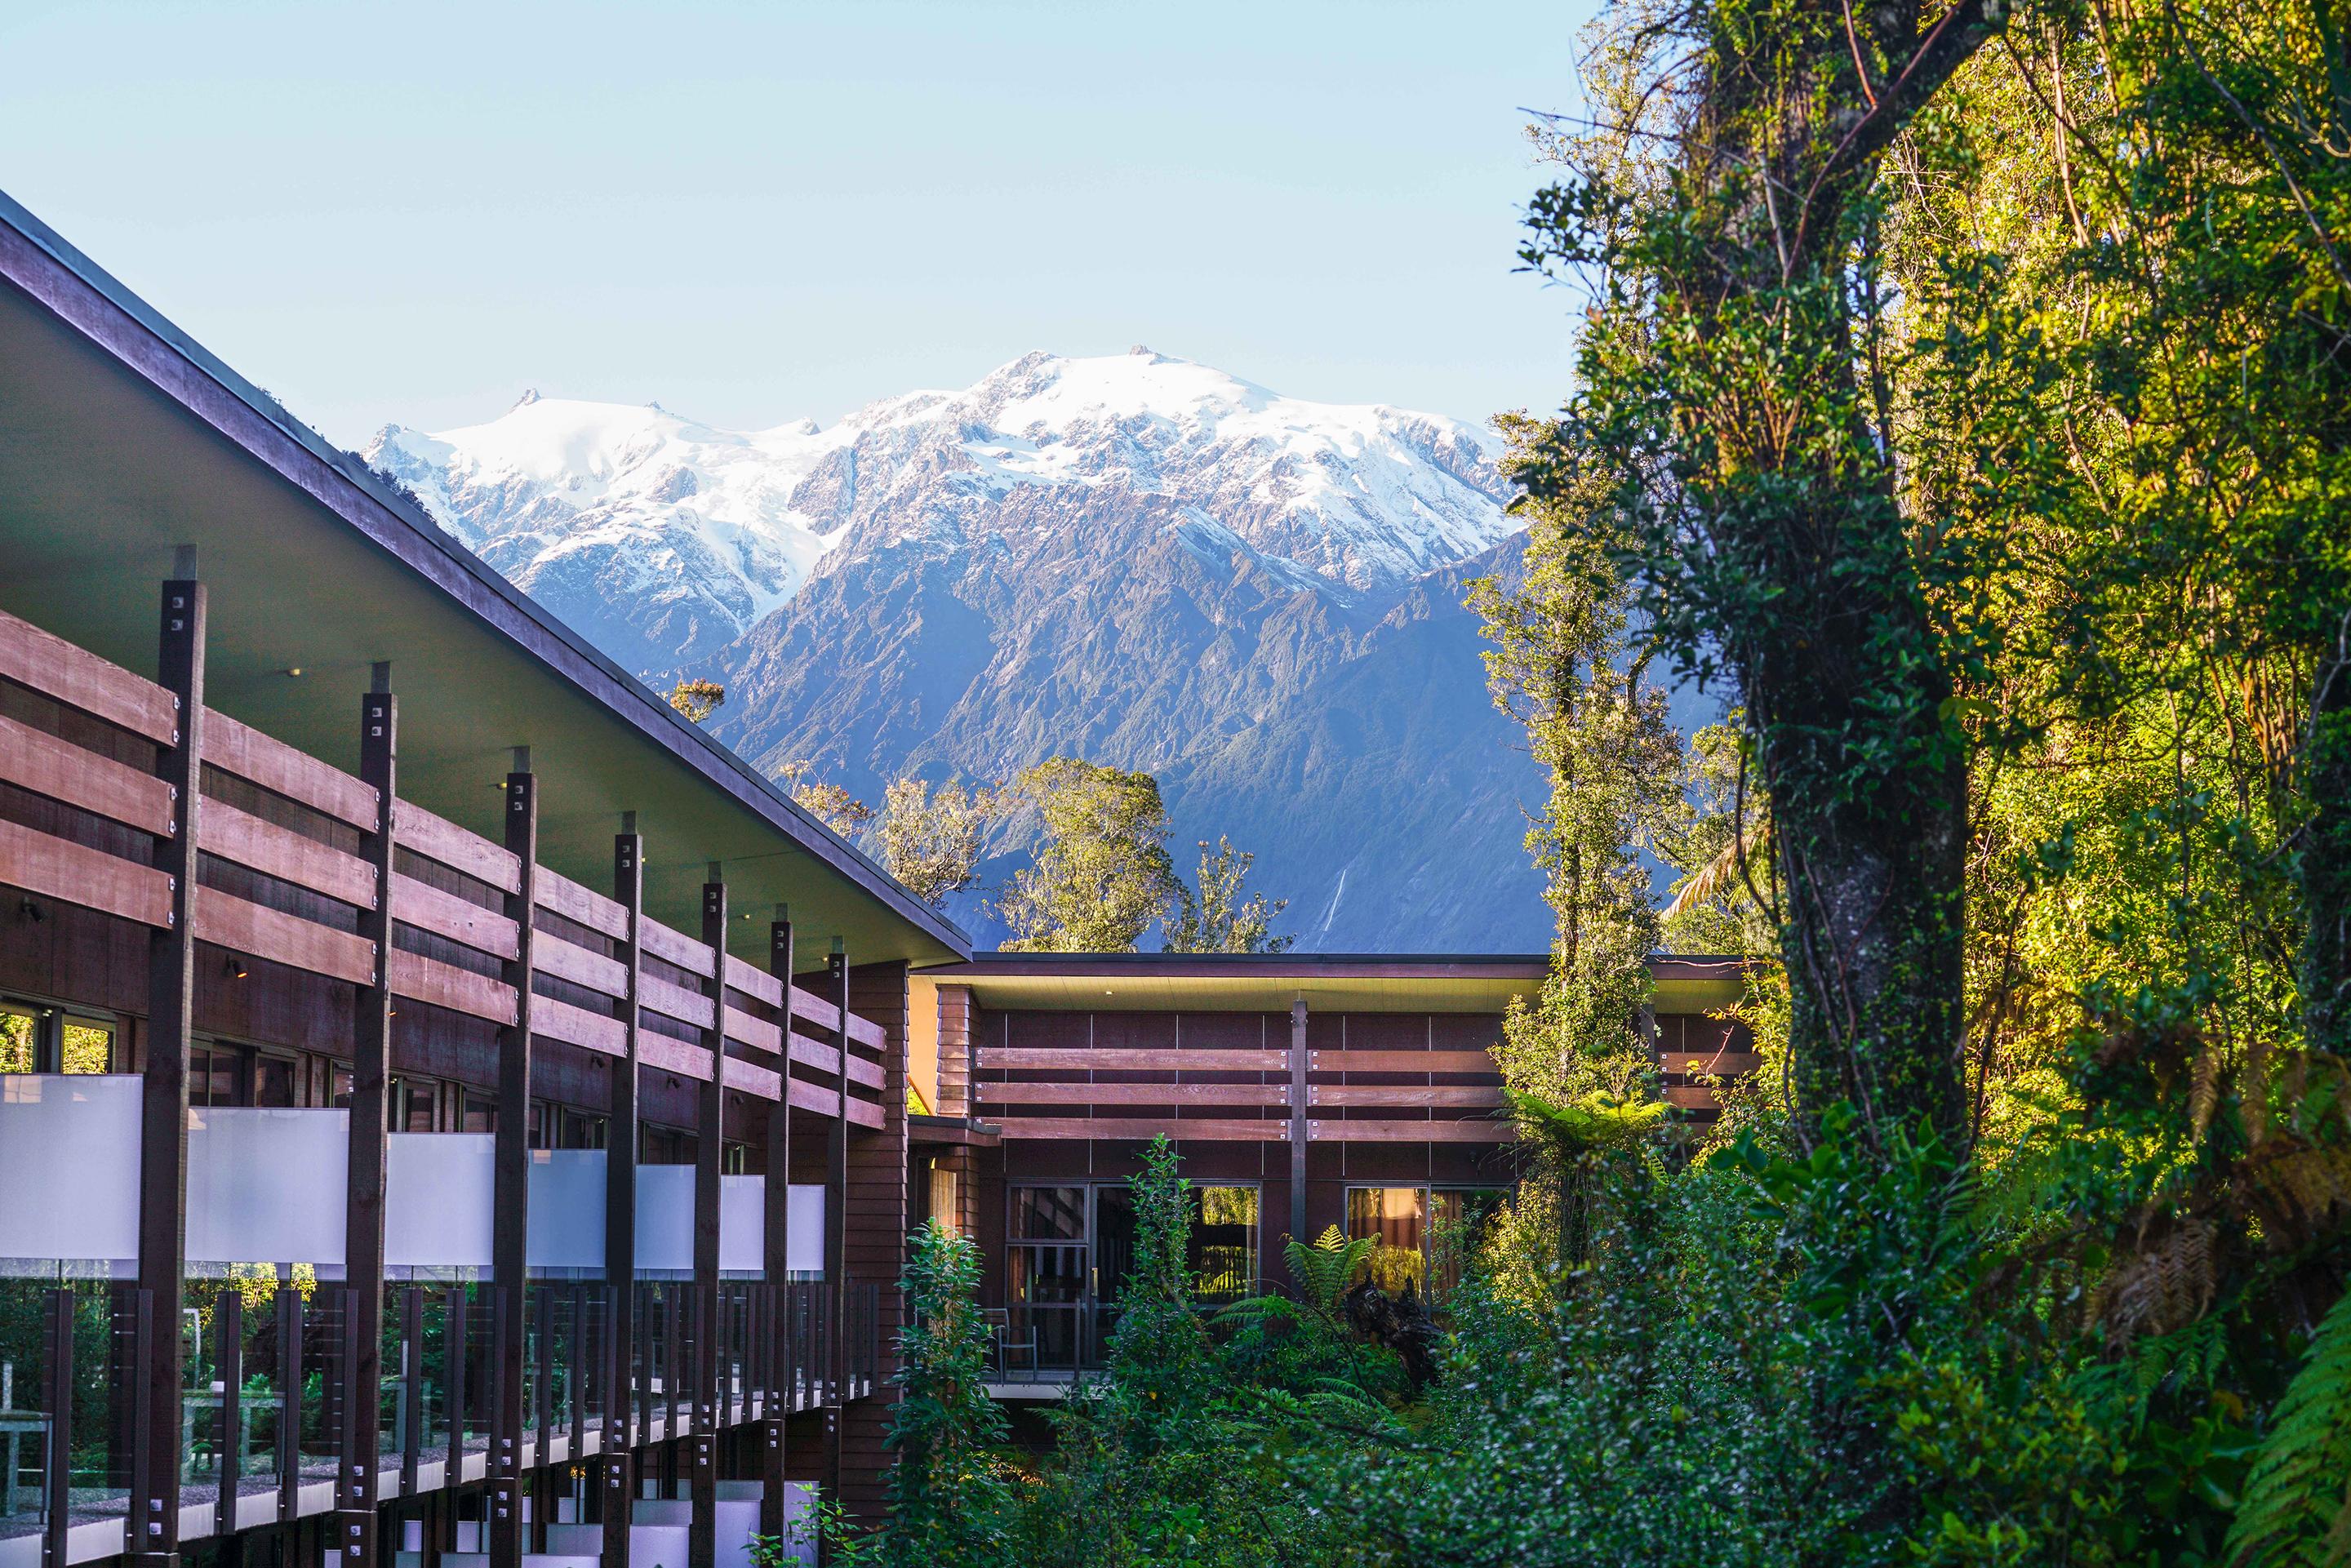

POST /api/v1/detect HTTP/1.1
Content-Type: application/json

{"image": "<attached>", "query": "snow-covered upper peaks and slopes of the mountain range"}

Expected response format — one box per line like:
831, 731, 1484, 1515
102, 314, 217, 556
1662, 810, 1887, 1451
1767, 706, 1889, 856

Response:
367, 348, 1512, 670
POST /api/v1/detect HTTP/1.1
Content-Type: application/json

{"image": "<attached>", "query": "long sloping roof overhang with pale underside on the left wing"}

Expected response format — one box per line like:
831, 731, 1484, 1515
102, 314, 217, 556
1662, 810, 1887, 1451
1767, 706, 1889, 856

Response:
0, 195, 971, 964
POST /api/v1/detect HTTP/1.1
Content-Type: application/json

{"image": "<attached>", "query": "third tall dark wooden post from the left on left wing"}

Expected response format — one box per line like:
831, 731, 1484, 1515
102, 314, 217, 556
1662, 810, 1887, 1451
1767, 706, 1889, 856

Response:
489, 748, 539, 1568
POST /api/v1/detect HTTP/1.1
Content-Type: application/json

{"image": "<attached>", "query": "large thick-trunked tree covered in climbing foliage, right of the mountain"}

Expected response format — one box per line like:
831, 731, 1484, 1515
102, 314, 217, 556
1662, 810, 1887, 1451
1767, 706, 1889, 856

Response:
1526, 0, 2003, 1140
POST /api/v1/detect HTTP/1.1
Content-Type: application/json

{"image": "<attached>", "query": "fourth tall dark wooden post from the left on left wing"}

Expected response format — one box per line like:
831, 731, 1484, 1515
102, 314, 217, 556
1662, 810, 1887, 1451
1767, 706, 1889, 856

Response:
602, 811, 644, 1563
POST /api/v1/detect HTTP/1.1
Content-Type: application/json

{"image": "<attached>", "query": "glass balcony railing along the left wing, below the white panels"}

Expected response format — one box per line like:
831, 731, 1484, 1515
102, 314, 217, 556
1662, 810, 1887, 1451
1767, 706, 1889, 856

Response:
0, 1279, 882, 1561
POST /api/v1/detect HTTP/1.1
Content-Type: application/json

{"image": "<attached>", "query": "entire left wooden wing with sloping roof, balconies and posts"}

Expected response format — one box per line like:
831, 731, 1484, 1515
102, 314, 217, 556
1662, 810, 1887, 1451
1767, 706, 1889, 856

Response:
0, 186, 969, 1568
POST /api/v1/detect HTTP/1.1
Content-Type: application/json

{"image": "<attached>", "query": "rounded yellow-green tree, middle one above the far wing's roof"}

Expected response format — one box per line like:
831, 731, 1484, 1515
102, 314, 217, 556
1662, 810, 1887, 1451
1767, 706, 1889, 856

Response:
997, 757, 1178, 952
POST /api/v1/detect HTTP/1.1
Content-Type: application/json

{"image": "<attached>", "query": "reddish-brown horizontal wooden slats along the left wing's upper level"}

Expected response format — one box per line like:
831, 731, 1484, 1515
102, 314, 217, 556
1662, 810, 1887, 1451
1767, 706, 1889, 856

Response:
0, 594, 887, 1126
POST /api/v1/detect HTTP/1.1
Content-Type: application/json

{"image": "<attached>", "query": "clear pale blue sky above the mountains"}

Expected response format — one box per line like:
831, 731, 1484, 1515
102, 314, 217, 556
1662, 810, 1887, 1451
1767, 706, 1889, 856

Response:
0, 0, 1592, 444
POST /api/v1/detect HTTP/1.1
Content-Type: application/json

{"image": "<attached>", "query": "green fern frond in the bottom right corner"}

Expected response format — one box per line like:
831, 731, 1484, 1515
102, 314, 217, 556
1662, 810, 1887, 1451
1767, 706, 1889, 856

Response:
2229, 1293, 2351, 1568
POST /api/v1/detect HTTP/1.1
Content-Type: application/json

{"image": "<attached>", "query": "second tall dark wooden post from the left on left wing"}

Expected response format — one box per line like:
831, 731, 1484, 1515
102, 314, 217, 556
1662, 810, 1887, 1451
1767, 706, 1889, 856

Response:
334, 663, 400, 1568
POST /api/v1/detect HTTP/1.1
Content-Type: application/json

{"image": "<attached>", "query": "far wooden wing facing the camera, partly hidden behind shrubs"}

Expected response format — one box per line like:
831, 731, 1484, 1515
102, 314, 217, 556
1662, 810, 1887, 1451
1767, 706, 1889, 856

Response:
910, 952, 1753, 1397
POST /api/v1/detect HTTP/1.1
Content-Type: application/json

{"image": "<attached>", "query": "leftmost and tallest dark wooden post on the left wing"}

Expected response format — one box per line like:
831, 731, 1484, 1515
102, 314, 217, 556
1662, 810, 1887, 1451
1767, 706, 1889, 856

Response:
122, 545, 205, 1568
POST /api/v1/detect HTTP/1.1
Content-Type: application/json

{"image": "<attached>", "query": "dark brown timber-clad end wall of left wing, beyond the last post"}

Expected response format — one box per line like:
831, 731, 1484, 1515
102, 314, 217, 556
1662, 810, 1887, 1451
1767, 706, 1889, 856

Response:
842, 964, 908, 1521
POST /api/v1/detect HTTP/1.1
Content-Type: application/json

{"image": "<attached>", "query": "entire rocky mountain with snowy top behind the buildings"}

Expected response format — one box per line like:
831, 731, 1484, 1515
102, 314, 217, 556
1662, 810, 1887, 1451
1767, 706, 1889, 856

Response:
367, 350, 1549, 952
